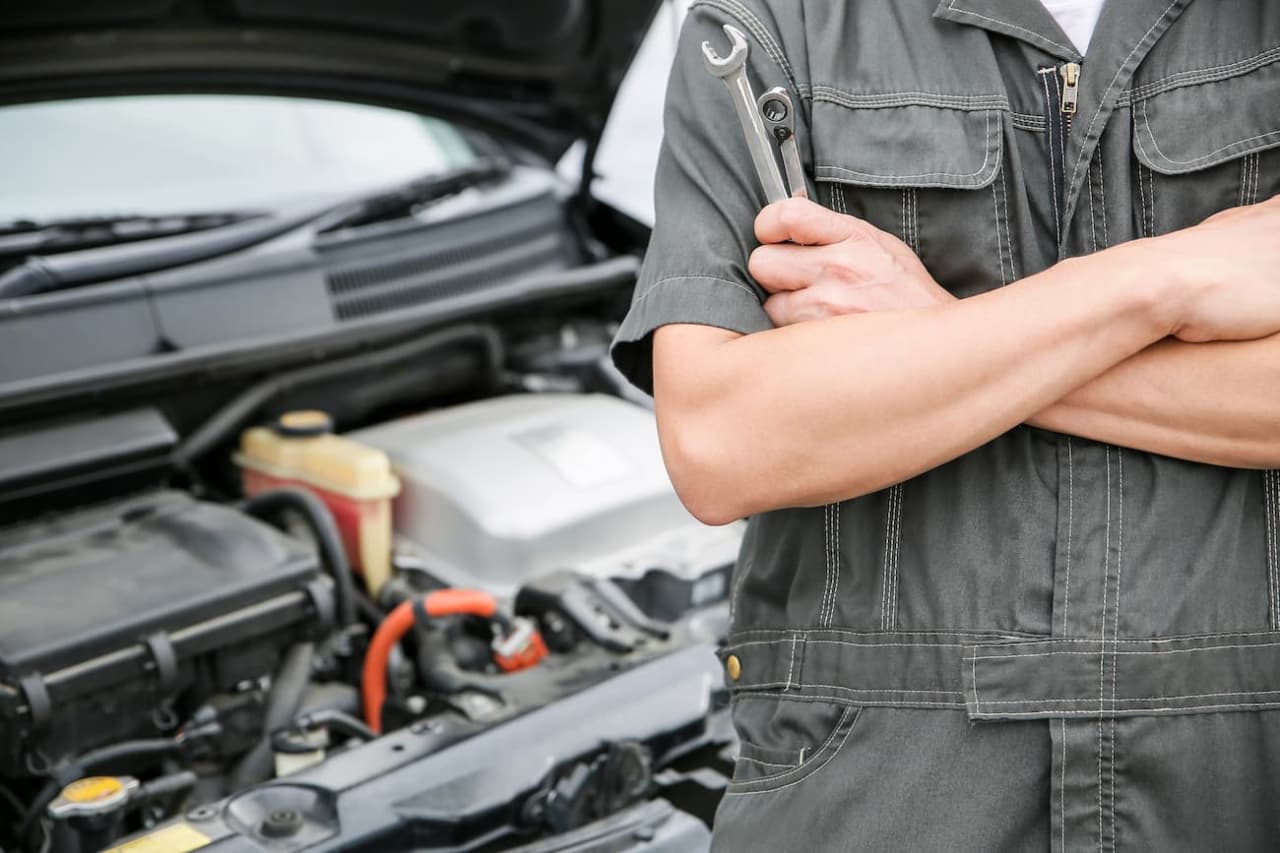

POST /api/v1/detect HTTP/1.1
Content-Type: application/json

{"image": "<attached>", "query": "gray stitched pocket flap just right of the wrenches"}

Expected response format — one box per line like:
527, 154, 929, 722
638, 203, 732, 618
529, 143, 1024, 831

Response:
810, 96, 1005, 190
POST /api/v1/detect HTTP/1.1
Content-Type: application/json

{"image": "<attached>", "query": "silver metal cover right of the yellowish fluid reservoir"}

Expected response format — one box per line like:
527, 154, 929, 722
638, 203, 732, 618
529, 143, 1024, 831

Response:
351, 394, 741, 596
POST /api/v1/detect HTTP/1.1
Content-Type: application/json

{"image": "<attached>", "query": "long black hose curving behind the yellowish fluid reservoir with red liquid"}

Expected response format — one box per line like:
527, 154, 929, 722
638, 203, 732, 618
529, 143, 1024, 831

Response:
172, 324, 504, 469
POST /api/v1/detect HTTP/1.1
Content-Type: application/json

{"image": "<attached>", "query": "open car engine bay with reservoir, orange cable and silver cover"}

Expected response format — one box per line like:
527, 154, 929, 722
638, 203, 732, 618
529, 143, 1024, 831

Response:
0, 314, 742, 853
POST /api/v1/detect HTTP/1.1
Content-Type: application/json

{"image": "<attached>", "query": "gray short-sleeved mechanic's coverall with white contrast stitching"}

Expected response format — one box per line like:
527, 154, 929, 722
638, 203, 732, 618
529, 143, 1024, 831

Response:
613, 0, 1280, 853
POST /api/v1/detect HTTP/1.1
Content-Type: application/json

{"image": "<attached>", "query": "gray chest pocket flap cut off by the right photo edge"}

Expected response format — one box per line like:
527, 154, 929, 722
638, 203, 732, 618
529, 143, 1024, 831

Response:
1133, 54, 1280, 174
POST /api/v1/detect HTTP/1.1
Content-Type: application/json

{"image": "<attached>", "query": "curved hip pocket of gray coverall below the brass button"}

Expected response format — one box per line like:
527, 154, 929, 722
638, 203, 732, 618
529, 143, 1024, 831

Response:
728, 693, 861, 794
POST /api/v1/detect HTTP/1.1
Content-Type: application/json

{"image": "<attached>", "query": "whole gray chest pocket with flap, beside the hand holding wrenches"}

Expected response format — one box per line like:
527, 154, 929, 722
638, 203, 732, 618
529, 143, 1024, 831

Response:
812, 98, 1020, 297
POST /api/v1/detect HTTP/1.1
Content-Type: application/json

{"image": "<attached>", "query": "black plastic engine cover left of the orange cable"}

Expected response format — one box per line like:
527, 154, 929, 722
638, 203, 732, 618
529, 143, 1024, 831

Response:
0, 492, 333, 775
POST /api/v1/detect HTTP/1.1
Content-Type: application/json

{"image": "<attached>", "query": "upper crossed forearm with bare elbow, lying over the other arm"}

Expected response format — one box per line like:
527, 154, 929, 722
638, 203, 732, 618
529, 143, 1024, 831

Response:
655, 240, 1170, 521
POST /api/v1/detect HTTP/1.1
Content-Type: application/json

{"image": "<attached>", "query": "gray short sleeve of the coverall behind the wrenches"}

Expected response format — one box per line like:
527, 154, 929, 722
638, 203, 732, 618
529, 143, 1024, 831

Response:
612, 5, 804, 393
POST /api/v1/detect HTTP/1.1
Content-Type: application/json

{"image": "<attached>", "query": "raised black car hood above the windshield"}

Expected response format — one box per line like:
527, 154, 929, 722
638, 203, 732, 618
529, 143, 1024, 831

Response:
0, 0, 660, 156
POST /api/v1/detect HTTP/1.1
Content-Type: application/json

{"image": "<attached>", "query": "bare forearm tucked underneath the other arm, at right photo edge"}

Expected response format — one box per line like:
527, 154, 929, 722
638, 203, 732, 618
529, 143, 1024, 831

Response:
1029, 336, 1280, 467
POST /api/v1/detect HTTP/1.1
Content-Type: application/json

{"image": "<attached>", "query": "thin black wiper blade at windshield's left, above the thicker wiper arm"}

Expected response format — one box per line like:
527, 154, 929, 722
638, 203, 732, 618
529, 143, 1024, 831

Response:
0, 210, 266, 257
